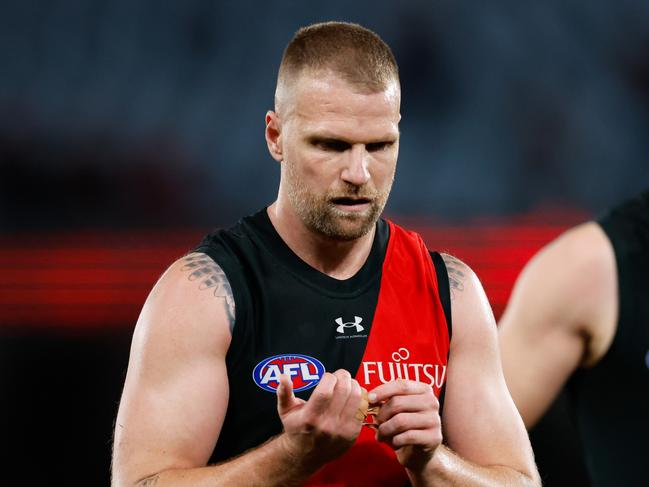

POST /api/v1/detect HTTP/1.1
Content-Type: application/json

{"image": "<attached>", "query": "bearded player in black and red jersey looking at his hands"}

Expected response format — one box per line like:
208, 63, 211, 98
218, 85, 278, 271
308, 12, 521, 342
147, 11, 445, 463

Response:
113, 23, 538, 486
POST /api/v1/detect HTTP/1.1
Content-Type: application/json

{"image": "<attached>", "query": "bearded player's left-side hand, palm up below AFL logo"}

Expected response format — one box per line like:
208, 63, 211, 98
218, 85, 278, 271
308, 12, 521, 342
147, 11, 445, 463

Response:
277, 369, 362, 471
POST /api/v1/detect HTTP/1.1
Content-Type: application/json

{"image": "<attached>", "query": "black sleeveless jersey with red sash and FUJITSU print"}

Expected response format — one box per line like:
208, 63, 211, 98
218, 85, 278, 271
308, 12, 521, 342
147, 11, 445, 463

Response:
196, 210, 451, 486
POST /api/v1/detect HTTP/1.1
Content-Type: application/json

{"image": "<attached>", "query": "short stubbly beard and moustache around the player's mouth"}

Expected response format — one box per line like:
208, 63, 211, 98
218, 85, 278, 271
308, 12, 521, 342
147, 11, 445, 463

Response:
286, 163, 394, 241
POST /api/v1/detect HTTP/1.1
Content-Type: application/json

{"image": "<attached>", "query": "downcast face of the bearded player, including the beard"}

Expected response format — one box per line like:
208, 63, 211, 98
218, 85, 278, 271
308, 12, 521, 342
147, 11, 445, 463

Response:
279, 74, 401, 240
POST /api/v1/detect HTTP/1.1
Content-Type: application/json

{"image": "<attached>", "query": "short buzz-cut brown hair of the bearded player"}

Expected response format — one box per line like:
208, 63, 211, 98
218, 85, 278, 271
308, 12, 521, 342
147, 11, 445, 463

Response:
277, 22, 399, 97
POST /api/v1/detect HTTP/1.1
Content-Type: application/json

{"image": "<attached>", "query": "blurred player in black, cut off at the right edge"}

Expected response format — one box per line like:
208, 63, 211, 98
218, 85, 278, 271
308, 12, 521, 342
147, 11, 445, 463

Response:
499, 191, 649, 486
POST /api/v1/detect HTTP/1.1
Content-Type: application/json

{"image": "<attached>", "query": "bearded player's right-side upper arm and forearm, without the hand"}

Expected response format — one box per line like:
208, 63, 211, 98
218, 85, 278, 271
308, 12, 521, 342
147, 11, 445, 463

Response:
418, 255, 540, 486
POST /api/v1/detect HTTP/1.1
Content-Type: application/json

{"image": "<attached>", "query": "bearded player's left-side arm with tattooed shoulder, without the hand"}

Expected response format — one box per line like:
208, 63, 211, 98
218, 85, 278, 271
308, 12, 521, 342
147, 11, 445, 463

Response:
112, 254, 332, 487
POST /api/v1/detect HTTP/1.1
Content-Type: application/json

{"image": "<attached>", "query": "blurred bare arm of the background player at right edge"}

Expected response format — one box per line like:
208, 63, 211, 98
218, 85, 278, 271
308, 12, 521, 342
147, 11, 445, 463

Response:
499, 223, 617, 428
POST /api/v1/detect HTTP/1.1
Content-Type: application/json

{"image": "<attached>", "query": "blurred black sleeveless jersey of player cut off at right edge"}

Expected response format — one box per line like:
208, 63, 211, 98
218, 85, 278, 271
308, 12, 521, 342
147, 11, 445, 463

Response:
568, 191, 649, 486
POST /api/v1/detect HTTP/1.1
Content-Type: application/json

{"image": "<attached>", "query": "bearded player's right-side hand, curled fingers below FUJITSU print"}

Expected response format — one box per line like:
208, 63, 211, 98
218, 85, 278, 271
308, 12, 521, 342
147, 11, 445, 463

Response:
368, 379, 442, 471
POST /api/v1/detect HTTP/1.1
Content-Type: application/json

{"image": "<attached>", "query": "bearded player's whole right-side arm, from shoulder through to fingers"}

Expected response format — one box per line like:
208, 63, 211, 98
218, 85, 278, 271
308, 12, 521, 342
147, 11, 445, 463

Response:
371, 255, 541, 486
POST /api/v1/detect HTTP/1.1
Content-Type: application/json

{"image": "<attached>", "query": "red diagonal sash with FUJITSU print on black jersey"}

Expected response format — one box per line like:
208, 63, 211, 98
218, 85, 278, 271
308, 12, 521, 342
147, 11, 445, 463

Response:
305, 221, 449, 487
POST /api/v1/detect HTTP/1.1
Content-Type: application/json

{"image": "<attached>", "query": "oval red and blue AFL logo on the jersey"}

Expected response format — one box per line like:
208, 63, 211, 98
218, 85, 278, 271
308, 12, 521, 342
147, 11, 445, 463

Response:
252, 354, 325, 392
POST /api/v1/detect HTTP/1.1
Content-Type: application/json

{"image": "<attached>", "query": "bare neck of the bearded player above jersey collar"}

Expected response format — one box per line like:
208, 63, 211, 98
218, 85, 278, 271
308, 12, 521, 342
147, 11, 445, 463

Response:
267, 202, 376, 280
